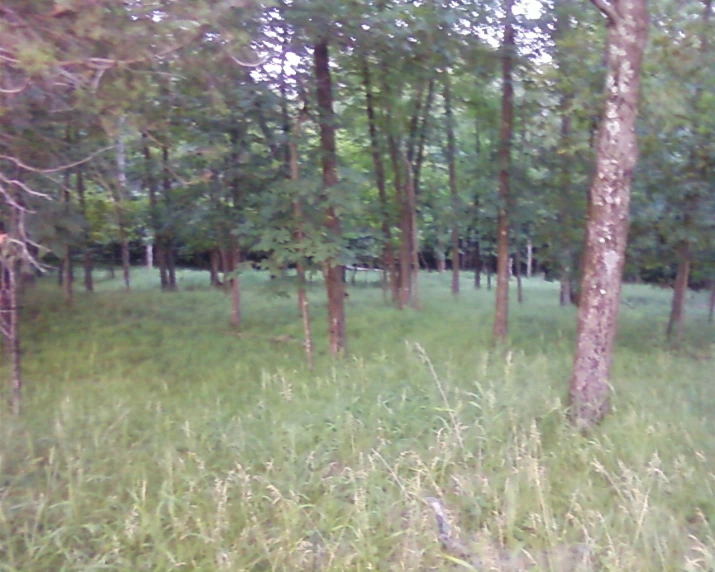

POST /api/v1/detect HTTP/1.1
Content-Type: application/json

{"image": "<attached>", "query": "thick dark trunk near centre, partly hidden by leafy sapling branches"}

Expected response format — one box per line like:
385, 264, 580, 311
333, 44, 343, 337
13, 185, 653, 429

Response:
313, 40, 346, 356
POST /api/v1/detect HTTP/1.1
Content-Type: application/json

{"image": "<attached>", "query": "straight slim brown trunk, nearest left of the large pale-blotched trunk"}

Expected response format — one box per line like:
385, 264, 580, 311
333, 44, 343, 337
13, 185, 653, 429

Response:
493, 0, 514, 341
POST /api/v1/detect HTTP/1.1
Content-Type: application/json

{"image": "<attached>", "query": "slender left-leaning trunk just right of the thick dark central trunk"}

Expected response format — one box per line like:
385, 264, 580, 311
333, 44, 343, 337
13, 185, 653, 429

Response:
362, 58, 398, 303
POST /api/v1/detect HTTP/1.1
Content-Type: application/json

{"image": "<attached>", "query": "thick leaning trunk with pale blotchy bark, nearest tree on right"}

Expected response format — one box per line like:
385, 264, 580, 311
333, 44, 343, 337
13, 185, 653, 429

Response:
569, 0, 648, 429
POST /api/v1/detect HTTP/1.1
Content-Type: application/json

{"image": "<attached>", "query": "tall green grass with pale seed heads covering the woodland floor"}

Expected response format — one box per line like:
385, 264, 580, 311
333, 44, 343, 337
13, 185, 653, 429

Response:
0, 270, 715, 572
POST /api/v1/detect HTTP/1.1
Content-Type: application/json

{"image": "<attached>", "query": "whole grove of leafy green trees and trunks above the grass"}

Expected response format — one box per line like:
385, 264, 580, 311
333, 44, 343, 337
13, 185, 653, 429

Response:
0, 0, 715, 427
